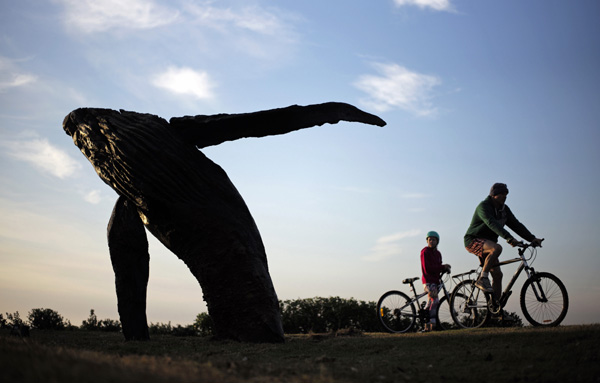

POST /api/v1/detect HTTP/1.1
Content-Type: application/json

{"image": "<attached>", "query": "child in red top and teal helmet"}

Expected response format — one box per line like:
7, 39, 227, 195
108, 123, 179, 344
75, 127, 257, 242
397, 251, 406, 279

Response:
421, 231, 450, 331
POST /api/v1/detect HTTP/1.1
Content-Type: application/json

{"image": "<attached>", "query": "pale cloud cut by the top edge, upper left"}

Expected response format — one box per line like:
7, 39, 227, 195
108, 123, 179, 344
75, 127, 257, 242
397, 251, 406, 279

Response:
56, 0, 179, 33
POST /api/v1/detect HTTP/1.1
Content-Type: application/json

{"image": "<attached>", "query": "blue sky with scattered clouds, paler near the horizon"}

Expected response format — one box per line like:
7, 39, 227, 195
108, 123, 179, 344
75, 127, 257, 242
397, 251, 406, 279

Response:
0, 0, 600, 325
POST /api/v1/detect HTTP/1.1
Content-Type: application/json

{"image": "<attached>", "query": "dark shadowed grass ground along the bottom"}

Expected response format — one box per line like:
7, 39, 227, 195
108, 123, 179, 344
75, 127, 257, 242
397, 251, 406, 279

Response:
0, 325, 600, 383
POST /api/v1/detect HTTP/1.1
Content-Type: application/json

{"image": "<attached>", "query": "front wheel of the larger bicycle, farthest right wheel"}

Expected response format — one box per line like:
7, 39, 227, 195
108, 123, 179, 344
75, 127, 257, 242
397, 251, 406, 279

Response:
521, 273, 569, 326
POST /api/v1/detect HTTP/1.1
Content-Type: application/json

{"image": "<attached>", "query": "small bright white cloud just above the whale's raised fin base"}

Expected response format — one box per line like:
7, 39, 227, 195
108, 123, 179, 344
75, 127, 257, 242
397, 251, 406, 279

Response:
152, 67, 214, 100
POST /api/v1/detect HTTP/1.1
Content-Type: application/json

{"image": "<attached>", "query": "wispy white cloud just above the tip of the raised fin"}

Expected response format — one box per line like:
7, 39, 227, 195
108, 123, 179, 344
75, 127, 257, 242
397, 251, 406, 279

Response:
354, 63, 441, 116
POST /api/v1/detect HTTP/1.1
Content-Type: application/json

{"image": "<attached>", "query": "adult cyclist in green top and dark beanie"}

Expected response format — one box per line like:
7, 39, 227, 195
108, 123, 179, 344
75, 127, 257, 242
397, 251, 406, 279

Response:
465, 183, 543, 299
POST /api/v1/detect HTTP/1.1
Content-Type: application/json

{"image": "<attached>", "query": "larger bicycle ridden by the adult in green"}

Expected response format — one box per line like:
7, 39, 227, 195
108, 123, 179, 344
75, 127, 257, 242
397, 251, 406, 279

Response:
450, 242, 569, 328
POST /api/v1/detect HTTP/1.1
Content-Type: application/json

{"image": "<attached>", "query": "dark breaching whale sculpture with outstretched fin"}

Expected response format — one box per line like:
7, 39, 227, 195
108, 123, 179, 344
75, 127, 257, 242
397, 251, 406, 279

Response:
63, 103, 385, 342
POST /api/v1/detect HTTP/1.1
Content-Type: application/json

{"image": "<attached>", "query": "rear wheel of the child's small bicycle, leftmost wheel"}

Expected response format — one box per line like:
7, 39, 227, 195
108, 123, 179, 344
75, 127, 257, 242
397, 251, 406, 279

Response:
377, 290, 417, 333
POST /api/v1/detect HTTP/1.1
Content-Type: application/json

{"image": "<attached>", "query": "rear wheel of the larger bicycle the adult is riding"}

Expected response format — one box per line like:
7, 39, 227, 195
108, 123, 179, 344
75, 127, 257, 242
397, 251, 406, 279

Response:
450, 279, 490, 328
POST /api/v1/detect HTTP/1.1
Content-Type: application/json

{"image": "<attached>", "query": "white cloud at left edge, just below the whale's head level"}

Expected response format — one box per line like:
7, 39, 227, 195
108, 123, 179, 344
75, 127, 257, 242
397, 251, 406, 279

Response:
2, 138, 81, 179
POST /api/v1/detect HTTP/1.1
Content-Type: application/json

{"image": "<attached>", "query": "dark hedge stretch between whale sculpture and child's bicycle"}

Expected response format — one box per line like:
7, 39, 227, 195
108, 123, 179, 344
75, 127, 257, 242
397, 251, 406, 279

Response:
279, 297, 379, 334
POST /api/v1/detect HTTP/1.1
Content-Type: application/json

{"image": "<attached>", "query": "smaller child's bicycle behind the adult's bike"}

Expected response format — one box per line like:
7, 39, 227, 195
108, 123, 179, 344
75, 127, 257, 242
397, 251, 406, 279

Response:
377, 271, 455, 333
